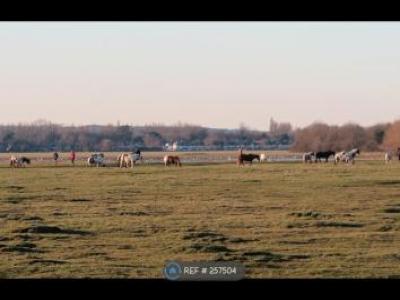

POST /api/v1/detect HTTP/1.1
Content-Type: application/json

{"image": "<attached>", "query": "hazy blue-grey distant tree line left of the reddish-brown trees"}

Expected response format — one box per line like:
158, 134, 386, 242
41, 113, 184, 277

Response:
0, 121, 294, 152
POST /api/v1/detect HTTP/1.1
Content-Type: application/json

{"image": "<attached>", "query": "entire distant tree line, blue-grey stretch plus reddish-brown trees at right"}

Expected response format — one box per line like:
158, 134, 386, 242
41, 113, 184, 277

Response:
0, 119, 400, 152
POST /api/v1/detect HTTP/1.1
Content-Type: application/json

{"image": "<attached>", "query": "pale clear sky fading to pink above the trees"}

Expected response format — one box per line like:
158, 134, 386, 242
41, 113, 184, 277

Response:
0, 22, 400, 130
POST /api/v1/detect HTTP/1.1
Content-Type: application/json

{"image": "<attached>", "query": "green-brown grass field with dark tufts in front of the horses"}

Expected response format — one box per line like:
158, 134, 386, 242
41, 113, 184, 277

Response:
0, 154, 400, 278
